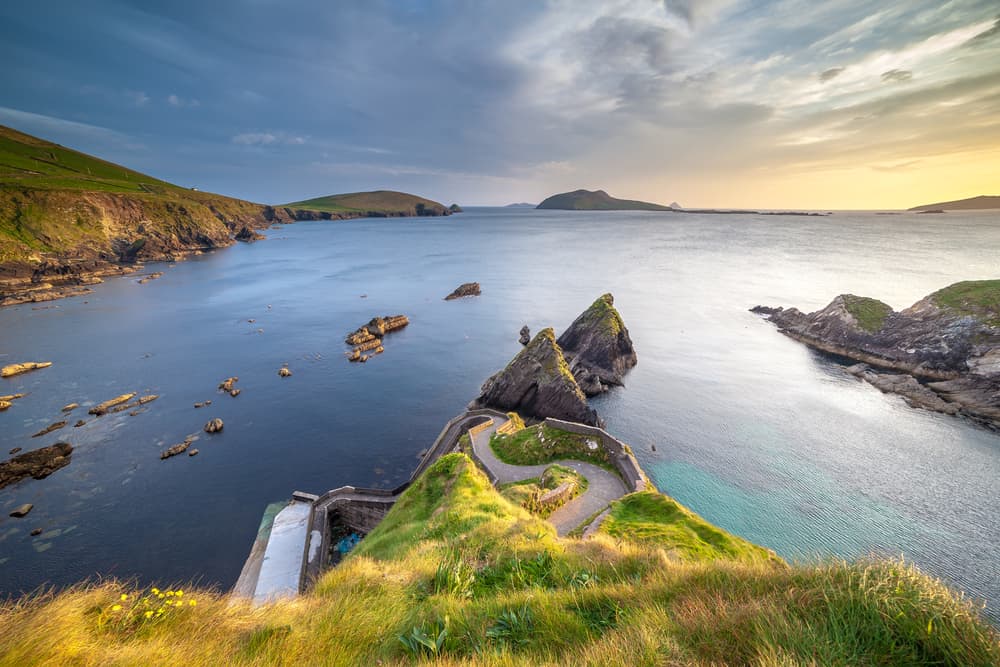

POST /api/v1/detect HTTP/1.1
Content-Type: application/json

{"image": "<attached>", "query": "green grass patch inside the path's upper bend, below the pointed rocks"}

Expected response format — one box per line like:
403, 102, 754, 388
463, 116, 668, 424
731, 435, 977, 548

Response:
490, 424, 614, 471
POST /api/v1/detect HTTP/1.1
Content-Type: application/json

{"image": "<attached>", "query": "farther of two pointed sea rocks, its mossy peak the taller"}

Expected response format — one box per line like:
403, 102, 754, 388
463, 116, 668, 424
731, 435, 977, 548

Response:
557, 294, 636, 396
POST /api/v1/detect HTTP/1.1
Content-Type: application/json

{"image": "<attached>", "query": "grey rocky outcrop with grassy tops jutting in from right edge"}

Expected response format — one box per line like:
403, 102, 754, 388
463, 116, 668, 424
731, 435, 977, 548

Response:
751, 280, 1000, 428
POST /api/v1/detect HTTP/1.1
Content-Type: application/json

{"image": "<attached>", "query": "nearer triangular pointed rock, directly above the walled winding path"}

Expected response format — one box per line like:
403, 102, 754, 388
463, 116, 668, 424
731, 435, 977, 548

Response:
475, 328, 601, 425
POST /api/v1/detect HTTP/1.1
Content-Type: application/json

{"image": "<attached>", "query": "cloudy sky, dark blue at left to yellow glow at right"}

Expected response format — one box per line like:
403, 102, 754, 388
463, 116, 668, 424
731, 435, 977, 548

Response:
0, 0, 1000, 209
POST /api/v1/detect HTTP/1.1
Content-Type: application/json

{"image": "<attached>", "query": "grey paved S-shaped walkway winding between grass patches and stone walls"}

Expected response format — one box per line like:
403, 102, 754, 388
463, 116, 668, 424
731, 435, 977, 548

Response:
472, 418, 627, 537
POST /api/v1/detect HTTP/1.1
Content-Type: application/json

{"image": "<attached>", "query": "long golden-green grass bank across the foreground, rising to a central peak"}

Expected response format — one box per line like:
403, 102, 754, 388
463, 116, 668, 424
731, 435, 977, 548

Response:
0, 454, 1000, 666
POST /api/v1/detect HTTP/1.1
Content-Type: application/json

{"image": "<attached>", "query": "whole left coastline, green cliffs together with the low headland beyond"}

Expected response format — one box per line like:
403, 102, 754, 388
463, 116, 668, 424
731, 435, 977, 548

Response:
0, 125, 452, 306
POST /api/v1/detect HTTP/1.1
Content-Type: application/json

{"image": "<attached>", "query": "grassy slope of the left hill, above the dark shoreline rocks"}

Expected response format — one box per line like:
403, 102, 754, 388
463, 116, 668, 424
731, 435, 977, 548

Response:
0, 126, 260, 263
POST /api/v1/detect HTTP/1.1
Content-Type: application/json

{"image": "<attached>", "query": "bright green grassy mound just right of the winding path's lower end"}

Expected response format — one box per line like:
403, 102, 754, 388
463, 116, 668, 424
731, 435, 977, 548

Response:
600, 491, 782, 565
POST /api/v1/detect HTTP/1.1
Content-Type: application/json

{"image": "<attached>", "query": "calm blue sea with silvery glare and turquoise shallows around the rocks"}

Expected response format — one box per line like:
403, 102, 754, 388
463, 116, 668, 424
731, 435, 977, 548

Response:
0, 209, 1000, 618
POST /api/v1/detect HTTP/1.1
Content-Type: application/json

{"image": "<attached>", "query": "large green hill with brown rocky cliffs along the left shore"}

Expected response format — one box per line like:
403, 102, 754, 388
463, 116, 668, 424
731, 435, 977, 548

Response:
0, 126, 267, 291
